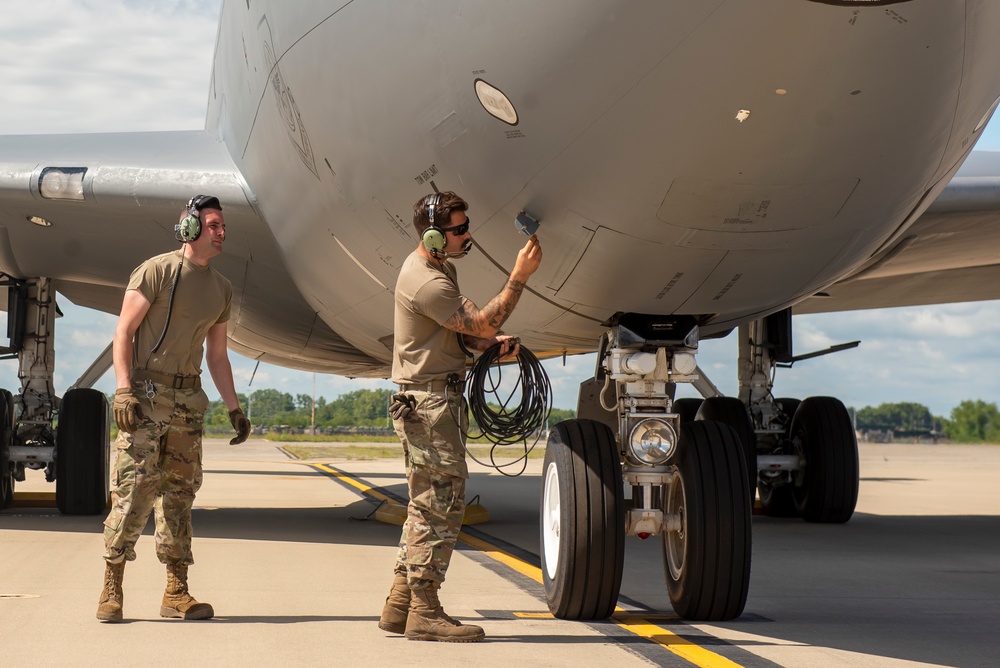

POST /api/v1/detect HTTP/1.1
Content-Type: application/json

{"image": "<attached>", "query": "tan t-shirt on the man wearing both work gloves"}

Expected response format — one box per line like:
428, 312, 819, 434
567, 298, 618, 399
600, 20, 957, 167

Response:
126, 251, 233, 376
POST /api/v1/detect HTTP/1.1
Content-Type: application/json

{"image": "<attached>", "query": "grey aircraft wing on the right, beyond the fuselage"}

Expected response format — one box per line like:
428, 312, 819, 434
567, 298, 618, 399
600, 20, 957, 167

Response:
794, 151, 1000, 314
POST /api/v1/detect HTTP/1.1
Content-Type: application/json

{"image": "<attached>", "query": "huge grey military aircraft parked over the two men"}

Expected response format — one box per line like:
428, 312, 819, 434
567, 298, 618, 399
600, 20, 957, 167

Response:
0, 0, 1000, 620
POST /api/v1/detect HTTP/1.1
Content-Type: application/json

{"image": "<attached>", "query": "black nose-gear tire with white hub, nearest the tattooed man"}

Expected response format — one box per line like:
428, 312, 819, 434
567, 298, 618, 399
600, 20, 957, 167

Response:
539, 420, 625, 619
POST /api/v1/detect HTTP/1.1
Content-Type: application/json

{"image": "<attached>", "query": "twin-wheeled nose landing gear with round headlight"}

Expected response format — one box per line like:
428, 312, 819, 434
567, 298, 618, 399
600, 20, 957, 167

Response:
541, 314, 751, 621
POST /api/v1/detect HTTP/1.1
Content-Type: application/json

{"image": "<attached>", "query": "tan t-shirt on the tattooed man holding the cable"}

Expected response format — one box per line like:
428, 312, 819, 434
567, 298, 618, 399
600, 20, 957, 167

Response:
392, 251, 467, 385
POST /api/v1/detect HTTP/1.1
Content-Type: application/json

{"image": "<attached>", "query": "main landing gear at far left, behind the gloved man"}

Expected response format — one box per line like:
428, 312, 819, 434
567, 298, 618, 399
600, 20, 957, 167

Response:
0, 277, 110, 515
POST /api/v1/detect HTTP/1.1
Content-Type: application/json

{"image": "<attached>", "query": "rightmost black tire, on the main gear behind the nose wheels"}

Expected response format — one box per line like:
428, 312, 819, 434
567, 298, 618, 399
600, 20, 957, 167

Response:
791, 397, 859, 524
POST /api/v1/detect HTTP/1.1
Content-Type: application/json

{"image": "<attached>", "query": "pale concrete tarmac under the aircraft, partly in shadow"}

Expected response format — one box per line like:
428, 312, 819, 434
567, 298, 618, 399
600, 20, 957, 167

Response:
0, 440, 1000, 668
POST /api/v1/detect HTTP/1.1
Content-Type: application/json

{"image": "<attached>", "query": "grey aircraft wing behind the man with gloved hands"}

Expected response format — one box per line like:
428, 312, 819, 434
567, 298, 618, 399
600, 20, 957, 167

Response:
0, 131, 386, 376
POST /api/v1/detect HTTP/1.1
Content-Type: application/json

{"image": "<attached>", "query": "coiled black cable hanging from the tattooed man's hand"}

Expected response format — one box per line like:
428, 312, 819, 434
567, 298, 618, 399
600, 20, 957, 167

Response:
465, 343, 552, 475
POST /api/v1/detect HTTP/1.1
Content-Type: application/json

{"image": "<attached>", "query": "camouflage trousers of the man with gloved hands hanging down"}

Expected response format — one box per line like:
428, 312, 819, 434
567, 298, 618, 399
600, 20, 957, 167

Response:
104, 382, 208, 564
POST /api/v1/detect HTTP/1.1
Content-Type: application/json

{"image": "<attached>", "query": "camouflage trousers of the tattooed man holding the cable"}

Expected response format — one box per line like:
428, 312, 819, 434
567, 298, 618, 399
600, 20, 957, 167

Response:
393, 392, 469, 588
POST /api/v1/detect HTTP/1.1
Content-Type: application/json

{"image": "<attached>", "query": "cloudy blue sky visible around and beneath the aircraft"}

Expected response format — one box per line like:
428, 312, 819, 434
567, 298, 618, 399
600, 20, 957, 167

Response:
0, 0, 1000, 416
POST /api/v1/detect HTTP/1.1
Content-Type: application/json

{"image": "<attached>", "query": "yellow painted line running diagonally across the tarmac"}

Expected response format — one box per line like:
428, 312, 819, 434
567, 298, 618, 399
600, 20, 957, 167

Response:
309, 464, 740, 668
